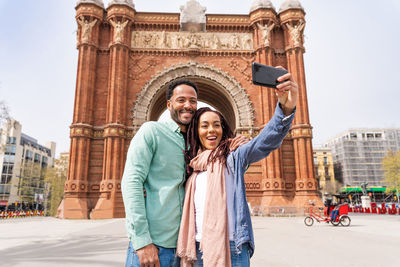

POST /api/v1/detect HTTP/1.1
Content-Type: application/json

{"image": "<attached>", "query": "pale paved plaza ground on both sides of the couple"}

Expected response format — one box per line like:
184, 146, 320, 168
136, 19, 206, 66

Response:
0, 216, 400, 267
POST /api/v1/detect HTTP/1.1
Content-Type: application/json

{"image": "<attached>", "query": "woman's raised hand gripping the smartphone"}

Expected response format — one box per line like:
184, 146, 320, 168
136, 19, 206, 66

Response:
275, 66, 299, 116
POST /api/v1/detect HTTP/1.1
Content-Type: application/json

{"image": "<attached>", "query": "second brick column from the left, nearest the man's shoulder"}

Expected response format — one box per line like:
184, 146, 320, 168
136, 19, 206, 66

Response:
90, 5, 135, 219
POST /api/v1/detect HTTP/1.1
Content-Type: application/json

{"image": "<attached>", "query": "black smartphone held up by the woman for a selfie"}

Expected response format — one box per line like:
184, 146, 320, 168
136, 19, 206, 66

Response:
251, 62, 288, 88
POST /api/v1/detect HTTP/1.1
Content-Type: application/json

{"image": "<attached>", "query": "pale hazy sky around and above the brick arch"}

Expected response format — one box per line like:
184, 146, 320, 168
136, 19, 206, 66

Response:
0, 0, 400, 158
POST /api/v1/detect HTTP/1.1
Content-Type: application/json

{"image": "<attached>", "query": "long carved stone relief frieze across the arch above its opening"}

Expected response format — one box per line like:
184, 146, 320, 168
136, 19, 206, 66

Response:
131, 31, 253, 50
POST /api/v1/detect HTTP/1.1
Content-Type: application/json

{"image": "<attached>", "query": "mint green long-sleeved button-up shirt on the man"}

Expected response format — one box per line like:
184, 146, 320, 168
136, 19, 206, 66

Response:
121, 120, 185, 249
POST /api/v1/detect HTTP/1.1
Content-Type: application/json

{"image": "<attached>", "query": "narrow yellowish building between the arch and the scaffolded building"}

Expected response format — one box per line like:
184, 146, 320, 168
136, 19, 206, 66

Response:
313, 147, 340, 196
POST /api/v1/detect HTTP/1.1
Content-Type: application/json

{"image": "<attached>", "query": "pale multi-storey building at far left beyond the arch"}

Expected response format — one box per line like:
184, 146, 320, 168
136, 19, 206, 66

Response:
0, 120, 56, 209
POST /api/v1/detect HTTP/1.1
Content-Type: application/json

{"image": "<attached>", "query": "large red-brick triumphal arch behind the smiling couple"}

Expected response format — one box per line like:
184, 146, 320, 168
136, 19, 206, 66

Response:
60, 0, 319, 218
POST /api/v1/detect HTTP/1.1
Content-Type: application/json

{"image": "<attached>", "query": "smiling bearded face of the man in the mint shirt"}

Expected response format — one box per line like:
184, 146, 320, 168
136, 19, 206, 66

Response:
167, 84, 197, 126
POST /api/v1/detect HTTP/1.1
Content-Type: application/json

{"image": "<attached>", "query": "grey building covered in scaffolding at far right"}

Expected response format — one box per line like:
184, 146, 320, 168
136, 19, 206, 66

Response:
324, 128, 400, 186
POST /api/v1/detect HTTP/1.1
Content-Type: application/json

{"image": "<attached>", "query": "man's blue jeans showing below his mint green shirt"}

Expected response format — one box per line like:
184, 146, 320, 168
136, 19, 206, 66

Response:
125, 242, 180, 267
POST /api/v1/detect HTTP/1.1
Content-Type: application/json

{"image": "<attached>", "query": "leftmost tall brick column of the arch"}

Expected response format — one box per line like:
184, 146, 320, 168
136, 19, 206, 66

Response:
60, 4, 104, 219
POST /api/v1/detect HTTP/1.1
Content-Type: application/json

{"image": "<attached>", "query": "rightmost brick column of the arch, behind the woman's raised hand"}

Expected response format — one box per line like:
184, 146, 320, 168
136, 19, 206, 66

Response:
280, 9, 321, 207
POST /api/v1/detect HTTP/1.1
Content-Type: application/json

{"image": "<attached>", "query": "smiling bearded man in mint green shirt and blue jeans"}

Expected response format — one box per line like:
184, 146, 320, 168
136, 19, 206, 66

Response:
122, 80, 198, 266
